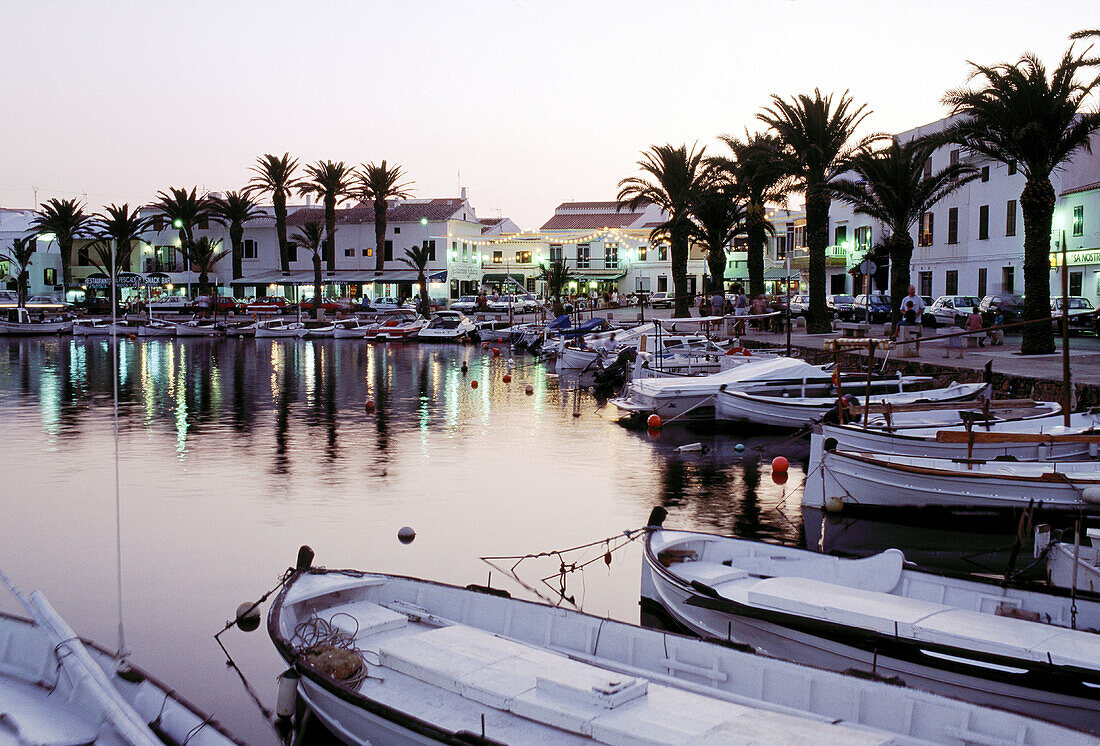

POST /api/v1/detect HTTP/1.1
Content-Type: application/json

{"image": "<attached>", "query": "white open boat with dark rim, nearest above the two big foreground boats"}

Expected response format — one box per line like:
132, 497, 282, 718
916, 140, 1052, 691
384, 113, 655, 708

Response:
802, 434, 1100, 515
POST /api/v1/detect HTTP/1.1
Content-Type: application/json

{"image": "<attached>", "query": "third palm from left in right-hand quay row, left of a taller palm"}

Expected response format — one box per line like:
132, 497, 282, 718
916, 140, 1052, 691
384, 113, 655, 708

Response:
716, 132, 788, 298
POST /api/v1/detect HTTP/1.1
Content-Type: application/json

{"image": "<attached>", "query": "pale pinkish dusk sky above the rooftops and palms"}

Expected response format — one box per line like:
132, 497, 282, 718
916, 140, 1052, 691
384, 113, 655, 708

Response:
0, 0, 1100, 229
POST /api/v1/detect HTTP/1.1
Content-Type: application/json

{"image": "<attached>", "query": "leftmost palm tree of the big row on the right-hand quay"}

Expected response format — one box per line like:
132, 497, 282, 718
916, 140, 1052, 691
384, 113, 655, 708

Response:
618, 145, 714, 317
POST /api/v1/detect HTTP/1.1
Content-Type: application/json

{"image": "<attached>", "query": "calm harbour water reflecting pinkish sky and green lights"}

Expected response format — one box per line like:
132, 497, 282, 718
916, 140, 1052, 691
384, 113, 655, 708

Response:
0, 338, 805, 743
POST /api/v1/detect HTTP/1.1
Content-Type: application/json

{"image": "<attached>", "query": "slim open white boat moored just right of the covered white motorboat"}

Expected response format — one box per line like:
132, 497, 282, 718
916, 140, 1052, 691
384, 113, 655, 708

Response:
715, 382, 992, 430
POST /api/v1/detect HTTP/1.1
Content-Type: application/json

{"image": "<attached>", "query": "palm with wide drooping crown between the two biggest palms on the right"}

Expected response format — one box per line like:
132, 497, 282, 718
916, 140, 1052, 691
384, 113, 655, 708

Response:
833, 139, 981, 322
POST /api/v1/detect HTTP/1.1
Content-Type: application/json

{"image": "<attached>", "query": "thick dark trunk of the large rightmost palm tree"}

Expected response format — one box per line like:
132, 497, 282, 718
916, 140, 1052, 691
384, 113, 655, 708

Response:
1020, 176, 1054, 355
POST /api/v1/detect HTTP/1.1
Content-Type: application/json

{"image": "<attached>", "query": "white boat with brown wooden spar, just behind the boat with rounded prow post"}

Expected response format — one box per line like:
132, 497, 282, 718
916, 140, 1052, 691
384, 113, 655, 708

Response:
811, 411, 1100, 462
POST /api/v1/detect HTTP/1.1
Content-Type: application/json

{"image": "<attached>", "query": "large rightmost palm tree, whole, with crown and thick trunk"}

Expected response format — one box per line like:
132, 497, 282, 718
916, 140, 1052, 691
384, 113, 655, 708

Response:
937, 45, 1100, 354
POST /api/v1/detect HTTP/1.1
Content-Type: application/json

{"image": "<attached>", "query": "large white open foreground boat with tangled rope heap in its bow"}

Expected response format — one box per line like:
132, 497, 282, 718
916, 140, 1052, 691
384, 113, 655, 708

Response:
261, 553, 1092, 746
